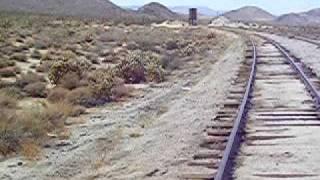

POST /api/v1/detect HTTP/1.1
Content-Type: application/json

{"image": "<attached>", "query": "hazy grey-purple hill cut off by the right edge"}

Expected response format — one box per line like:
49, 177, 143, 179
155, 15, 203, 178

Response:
274, 8, 320, 26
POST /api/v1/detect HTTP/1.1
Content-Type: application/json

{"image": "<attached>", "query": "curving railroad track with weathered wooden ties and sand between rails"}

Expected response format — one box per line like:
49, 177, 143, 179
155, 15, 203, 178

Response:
182, 38, 320, 180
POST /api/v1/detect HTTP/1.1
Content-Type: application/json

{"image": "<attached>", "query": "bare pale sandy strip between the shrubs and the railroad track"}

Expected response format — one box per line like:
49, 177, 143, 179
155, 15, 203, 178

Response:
0, 29, 244, 180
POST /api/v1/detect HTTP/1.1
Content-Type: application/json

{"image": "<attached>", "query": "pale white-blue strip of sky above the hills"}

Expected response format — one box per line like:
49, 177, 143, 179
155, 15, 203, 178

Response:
111, 0, 320, 15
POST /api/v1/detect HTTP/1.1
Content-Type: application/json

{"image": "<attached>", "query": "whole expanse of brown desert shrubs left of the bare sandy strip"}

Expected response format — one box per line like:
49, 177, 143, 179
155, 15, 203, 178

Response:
0, 11, 217, 158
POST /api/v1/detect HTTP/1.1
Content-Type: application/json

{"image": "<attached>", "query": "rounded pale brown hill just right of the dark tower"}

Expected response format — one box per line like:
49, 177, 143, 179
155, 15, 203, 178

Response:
224, 6, 275, 22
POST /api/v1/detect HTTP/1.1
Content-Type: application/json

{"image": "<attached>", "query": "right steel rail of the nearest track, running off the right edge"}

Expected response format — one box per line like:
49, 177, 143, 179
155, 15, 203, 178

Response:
271, 41, 320, 105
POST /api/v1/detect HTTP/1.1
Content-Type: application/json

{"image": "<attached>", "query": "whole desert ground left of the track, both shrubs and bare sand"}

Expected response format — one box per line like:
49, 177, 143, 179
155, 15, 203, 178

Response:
0, 11, 245, 179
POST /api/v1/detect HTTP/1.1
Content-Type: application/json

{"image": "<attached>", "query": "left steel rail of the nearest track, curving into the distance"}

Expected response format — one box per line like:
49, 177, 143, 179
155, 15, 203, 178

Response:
214, 40, 257, 180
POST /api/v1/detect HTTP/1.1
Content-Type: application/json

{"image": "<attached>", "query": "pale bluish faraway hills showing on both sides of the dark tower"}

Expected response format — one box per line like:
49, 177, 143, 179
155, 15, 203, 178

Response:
169, 6, 223, 17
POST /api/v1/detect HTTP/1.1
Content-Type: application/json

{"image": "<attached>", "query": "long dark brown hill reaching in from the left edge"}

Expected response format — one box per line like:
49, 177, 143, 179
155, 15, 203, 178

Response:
0, 0, 135, 18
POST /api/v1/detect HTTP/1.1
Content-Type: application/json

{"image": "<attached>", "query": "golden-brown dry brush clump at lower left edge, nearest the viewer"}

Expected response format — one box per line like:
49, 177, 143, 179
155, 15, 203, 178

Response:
0, 90, 74, 159
